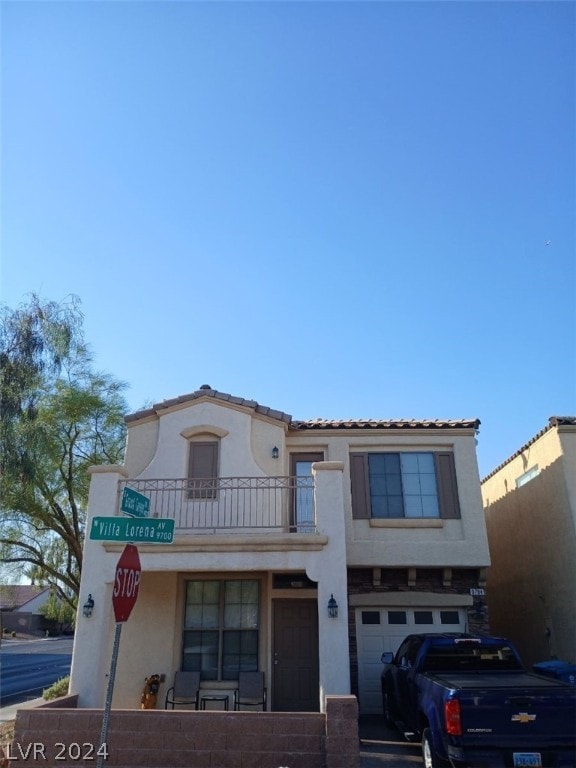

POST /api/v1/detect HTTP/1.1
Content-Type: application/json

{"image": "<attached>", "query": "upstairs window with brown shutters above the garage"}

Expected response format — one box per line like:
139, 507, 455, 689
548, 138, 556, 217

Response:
350, 452, 460, 519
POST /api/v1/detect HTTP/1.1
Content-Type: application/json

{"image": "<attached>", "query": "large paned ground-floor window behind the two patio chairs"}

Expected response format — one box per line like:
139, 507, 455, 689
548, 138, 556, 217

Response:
182, 579, 260, 680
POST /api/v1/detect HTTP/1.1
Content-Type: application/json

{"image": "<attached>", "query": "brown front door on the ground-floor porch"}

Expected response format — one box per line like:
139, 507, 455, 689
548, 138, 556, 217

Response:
272, 600, 320, 712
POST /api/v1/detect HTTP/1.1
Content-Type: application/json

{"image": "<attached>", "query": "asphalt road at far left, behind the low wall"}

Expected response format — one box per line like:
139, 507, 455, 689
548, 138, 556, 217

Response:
0, 637, 73, 707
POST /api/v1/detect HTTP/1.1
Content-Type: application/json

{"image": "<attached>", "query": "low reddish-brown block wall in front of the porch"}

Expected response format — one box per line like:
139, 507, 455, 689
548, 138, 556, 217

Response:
11, 696, 360, 768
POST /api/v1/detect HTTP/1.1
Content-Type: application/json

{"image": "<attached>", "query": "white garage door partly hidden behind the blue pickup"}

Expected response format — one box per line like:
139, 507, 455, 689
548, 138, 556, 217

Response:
356, 606, 466, 715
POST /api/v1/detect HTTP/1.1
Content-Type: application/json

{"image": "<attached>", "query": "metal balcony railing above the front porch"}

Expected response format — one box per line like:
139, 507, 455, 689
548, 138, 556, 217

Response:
117, 477, 317, 534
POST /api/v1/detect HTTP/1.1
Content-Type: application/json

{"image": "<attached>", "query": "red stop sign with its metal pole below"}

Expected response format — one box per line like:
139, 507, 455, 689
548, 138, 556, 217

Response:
96, 544, 142, 768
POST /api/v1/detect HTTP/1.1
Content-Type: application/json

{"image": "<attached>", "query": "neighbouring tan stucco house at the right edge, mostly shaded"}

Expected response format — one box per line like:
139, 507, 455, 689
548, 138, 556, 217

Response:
482, 416, 576, 665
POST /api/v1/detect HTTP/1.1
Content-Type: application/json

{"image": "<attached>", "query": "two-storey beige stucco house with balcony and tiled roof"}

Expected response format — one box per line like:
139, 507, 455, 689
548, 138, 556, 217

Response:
71, 385, 489, 713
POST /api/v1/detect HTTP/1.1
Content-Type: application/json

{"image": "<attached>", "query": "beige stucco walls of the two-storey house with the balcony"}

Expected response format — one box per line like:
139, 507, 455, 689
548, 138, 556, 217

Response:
71, 398, 489, 708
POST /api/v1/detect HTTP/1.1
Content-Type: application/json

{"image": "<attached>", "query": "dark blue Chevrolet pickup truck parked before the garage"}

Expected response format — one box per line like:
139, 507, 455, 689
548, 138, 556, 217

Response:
382, 634, 576, 768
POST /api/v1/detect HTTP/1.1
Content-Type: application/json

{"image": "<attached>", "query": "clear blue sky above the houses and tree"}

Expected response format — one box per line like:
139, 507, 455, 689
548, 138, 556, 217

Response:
1, 0, 576, 475
